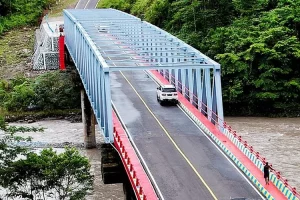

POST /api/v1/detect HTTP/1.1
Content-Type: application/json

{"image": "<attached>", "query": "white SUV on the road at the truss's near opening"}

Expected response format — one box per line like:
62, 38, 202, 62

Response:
156, 85, 178, 104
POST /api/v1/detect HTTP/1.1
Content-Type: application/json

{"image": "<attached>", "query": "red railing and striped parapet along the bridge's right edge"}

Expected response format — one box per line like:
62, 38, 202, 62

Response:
162, 70, 300, 199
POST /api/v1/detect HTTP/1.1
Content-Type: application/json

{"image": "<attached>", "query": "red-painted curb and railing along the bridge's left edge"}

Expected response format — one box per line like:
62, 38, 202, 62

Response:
113, 112, 158, 200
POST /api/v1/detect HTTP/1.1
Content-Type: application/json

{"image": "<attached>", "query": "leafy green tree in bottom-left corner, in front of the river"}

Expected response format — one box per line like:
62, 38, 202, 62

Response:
0, 116, 93, 200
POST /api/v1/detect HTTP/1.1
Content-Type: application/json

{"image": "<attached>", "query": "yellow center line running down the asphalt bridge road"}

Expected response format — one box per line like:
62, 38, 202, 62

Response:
120, 71, 218, 200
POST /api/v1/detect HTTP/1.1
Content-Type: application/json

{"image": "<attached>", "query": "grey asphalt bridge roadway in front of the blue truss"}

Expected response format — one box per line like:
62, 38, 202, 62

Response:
111, 71, 261, 200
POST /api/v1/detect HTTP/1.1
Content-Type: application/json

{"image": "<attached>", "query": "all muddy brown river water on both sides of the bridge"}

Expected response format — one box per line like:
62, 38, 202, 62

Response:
4, 117, 300, 200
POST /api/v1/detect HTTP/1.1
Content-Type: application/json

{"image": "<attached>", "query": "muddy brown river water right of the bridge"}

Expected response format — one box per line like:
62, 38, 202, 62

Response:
225, 117, 300, 191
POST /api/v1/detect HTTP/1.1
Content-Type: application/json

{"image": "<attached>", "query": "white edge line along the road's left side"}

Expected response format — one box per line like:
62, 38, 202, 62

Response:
111, 101, 165, 200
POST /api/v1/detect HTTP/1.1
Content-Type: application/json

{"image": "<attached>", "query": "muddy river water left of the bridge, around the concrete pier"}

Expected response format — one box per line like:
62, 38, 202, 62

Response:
9, 119, 124, 200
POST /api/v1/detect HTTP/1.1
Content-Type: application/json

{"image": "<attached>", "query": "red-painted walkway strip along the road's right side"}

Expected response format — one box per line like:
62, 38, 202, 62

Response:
150, 70, 287, 200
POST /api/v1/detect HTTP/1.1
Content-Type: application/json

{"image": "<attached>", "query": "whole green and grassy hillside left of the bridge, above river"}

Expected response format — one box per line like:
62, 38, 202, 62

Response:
0, 0, 80, 115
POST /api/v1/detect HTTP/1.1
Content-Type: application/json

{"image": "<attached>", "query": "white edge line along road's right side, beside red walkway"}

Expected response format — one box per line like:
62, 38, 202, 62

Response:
177, 105, 265, 199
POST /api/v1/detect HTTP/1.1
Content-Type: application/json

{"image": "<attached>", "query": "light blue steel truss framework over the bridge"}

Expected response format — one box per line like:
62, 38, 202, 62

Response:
64, 9, 223, 143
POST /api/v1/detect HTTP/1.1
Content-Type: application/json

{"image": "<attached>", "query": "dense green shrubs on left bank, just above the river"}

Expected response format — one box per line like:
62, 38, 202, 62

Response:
0, 71, 80, 111
